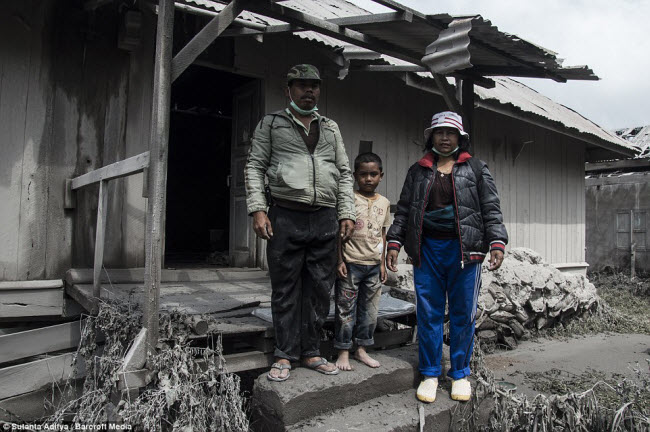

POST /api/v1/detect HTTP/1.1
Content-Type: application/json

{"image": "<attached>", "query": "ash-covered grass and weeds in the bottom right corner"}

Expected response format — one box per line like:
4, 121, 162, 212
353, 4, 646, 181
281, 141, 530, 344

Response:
453, 344, 650, 432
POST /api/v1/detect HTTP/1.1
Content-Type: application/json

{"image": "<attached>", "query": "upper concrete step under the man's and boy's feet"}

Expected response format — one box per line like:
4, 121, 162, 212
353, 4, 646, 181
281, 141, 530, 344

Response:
252, 346, 420, 431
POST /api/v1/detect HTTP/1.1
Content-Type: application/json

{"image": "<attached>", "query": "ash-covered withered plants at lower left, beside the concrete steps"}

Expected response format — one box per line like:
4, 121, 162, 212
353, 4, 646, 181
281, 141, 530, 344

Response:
47, 302, 248, 431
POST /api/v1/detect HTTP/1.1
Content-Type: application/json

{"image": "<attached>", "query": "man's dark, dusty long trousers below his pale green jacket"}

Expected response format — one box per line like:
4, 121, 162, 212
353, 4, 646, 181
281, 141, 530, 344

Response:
266, 206, 338, 361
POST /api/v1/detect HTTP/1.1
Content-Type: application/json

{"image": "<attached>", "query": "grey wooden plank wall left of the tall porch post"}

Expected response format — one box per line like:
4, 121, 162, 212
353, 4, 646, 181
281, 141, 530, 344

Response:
0, 0, 148, 280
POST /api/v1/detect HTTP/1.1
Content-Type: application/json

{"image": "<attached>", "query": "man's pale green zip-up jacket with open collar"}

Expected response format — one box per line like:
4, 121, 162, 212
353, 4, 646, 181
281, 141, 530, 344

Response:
245, 111, 356, 220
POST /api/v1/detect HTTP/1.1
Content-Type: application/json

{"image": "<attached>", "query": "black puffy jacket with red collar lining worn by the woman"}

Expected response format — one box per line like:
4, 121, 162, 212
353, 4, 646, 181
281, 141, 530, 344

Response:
386, 152, 508, 267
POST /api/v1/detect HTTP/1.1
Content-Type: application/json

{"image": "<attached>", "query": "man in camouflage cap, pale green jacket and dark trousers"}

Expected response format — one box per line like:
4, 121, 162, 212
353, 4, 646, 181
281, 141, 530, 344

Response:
245, 64, 355, 381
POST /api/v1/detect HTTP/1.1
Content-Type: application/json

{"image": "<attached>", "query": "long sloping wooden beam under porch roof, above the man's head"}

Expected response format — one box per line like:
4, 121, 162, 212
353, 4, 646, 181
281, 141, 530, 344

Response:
247, 2, 422, 65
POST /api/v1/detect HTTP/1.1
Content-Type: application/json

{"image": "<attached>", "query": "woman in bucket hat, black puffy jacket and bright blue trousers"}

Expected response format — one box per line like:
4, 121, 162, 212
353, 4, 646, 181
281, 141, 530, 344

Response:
386, 111, 508, 402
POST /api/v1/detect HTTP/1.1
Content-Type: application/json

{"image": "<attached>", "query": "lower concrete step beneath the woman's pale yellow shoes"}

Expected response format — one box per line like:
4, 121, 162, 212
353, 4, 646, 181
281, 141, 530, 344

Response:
287, 381, 459, 432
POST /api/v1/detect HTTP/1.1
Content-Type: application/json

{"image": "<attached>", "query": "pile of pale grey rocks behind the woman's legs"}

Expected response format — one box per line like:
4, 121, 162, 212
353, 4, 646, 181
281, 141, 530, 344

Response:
384, 248, 600, 348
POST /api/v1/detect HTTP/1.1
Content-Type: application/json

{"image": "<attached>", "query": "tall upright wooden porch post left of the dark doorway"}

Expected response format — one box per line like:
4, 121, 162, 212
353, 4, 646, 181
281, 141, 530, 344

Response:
144, 0, 174, 360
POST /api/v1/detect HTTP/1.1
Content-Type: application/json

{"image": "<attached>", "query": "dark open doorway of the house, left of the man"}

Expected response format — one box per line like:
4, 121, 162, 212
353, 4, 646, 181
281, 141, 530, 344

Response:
165, 65, 252, 267
